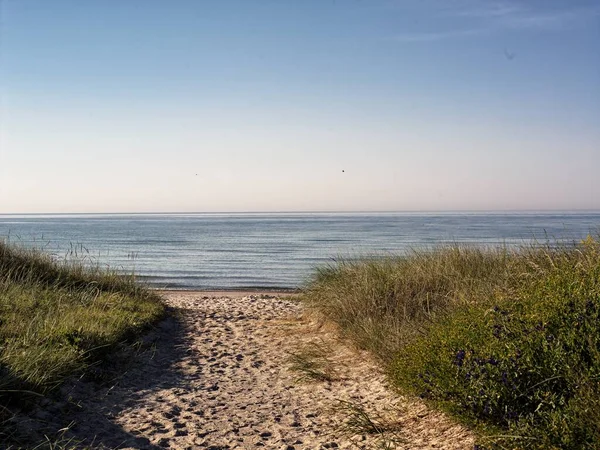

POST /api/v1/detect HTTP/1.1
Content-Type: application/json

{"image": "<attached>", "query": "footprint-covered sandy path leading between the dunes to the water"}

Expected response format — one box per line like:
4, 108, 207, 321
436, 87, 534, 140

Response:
21, 291, 473, 450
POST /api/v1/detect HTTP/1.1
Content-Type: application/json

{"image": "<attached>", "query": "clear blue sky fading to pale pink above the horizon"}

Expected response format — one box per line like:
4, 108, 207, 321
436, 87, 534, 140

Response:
0, 0, 600, 214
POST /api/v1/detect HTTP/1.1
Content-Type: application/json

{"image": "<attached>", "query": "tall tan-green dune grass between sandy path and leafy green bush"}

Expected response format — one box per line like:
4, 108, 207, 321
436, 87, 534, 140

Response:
304, 246, 523, 361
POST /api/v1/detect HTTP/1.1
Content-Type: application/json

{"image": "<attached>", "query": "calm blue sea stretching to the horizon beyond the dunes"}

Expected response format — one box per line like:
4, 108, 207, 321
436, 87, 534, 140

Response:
0, 212, 600, 289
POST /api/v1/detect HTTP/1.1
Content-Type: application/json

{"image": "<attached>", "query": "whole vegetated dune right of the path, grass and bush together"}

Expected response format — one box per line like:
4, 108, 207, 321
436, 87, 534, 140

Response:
304, 238, 600, 449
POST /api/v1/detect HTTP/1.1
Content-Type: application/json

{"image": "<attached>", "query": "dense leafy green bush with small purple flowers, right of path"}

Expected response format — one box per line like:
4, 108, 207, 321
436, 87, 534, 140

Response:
390, 239, 600, 449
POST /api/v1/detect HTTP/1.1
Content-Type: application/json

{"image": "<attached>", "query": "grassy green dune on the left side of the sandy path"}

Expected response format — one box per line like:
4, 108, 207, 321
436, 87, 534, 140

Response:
0, 242, 165, 442
